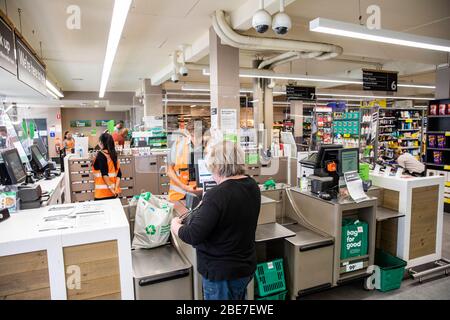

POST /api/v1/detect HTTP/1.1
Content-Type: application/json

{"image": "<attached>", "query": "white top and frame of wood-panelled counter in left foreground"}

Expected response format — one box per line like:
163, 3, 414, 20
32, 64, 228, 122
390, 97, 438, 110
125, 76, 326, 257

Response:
0, 199, 134, 299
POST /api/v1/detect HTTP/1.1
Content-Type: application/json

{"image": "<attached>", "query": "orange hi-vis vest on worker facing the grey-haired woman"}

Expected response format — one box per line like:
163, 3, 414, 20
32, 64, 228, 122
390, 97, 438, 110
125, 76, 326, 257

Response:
169, 138, 196, 201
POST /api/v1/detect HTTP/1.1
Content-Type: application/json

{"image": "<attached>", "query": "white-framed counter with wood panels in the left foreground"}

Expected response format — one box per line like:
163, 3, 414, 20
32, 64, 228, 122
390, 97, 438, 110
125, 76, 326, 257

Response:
0, 200, 134, 300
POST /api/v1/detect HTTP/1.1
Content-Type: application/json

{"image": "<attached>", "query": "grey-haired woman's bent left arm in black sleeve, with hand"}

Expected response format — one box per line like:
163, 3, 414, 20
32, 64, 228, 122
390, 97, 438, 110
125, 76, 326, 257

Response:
172, 195, 220, 246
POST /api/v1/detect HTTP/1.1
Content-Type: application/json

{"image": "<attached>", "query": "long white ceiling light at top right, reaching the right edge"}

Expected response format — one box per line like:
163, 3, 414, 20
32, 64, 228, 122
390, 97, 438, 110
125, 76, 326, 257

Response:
309, 18, 450, 52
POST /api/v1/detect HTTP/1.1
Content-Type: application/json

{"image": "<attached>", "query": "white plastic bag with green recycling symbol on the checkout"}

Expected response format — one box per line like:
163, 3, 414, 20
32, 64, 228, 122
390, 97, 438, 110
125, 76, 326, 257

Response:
132, 192, 173, 249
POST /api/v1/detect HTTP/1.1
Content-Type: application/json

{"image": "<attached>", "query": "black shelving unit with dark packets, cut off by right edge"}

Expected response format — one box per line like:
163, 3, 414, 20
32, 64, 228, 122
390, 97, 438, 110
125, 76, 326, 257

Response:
425, 99, 450, 212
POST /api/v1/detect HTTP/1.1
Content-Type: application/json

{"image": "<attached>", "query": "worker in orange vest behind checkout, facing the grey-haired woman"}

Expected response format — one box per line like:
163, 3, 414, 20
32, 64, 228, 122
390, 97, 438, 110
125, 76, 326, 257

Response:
167, 119, 205, 201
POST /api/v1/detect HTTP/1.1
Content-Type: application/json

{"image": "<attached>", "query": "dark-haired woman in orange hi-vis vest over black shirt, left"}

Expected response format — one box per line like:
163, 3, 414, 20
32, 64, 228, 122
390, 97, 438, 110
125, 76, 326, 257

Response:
92, 133, 122, 200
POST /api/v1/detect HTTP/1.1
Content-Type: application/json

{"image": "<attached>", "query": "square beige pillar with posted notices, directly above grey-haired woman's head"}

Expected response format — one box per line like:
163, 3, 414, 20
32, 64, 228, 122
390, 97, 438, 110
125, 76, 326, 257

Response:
209, 28, 241, 130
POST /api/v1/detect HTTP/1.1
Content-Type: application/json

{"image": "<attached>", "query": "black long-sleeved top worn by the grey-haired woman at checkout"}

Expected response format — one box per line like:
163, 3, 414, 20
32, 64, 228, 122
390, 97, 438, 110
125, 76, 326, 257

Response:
179, 178, 261, 281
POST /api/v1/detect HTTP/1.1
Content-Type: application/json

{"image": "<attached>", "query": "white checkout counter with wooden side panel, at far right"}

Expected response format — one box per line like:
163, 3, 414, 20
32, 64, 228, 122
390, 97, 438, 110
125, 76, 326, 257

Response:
370, 172, 445, 268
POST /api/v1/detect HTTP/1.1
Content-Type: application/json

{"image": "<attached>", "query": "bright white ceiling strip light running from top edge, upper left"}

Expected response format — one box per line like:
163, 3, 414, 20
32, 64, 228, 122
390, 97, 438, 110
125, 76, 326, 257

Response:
99, 0, 132, 98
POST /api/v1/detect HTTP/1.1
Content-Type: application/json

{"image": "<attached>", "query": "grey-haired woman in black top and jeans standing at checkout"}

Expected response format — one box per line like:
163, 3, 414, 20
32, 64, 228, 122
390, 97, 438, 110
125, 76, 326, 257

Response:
172, 141, 261, 300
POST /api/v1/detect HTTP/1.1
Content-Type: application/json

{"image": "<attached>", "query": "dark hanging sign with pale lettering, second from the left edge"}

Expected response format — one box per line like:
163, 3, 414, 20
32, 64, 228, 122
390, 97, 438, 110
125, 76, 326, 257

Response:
16, 35, 47, 95
